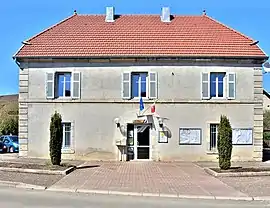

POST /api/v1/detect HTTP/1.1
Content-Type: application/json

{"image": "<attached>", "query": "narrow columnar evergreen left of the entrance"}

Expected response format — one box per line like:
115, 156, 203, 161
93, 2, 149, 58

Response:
50, 111, 63, 165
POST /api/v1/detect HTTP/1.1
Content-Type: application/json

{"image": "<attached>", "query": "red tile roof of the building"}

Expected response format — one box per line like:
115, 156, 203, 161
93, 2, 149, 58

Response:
15, 14, 266, 58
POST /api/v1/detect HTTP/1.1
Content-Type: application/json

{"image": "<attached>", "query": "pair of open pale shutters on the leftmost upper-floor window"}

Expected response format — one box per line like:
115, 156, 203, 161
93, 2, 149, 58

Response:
46, 72, 81, 99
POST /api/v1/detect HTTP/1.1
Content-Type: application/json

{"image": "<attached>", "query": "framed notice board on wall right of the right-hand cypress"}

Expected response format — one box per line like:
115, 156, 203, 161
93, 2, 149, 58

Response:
232, 128, 253, 145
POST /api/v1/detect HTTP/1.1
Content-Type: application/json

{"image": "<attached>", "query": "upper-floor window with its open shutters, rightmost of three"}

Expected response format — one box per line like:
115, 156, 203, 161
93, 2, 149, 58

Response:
201, 72, 236, 99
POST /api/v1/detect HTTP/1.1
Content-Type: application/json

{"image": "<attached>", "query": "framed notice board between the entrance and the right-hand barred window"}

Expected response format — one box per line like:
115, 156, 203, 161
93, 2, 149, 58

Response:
179, 128, 202, 145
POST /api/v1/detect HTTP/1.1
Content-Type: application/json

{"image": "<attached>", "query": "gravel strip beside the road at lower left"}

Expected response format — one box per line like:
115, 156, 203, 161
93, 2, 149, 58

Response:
0, 171, 64, 187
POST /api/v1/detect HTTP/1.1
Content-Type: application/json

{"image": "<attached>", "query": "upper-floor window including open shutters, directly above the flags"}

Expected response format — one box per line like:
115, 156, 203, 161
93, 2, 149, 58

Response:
122, 72, 157, 99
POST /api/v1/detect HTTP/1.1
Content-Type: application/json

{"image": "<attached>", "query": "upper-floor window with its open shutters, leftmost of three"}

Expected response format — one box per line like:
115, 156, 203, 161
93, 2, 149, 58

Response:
46, 72, 81, 99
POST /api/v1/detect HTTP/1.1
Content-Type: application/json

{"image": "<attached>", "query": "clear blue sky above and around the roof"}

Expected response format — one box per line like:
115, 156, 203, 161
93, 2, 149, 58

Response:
0, 0, 270, 95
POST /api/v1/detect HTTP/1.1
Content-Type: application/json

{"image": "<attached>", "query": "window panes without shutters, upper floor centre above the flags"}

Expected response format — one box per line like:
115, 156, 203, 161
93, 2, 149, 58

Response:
131, 73, 148, 98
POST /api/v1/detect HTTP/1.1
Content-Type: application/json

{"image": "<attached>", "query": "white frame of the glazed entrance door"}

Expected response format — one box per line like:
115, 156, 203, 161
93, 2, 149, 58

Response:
133, 124, 152, 161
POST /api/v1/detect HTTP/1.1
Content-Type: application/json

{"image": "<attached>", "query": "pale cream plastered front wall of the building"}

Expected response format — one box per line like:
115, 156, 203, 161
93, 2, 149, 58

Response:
19, 60, 263, 161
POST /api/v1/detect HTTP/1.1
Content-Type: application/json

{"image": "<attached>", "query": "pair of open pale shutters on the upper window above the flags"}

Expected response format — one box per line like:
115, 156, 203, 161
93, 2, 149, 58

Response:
122, 72, 157, 99
